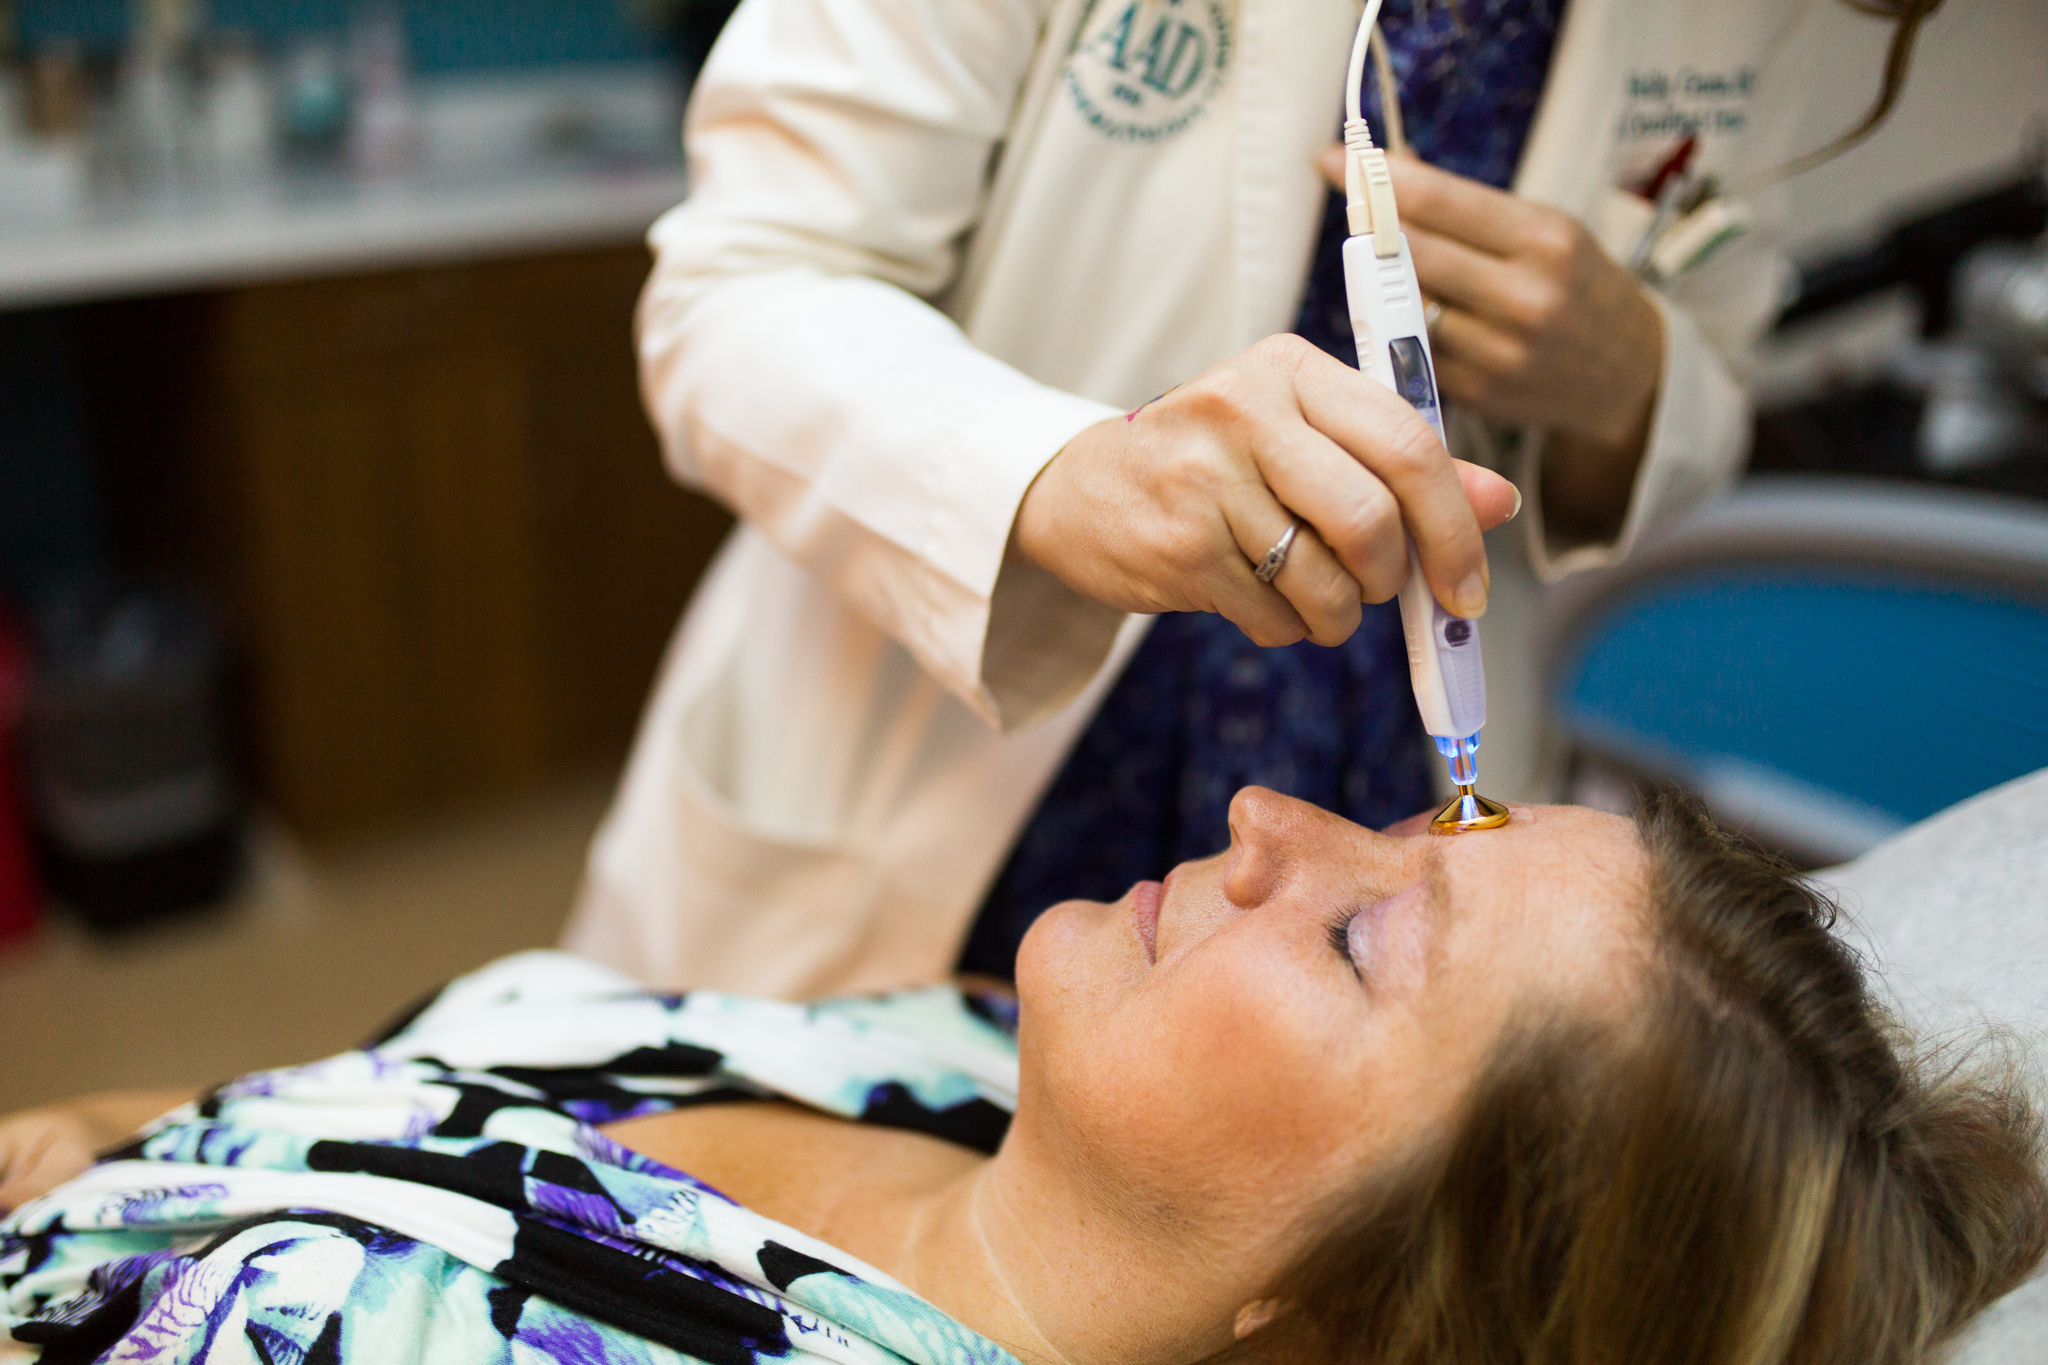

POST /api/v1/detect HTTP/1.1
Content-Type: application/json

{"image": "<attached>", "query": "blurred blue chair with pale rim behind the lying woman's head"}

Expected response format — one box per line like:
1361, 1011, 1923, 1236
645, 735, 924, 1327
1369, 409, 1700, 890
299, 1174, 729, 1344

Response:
1546, 477, 2048, 862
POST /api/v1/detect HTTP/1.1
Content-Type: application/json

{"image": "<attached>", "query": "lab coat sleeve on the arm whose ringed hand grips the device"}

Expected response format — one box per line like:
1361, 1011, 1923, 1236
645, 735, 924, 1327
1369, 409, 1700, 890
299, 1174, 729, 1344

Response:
637, 0, 1122, 729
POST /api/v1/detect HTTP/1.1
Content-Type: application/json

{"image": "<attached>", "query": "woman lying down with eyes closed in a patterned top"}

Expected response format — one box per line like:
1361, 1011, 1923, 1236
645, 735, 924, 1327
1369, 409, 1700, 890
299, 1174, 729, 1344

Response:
0, 788, 2048, 1365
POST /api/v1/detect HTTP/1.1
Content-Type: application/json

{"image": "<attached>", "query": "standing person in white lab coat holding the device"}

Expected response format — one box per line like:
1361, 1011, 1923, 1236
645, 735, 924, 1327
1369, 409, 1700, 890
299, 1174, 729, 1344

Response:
565, 0, 1931, 997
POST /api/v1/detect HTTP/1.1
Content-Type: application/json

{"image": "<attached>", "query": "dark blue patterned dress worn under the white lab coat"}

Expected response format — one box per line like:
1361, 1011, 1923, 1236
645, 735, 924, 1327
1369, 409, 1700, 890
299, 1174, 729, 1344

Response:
961, 0, 1565, 976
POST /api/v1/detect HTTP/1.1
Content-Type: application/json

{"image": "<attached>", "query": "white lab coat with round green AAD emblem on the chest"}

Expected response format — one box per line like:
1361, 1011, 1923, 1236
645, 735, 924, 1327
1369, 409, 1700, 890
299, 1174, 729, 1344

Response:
565, 0, 1817, 997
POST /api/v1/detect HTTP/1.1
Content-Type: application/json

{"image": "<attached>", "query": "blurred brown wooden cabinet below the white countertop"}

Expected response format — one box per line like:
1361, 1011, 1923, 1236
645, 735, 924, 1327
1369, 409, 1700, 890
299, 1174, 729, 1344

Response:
88, 246, 729, 837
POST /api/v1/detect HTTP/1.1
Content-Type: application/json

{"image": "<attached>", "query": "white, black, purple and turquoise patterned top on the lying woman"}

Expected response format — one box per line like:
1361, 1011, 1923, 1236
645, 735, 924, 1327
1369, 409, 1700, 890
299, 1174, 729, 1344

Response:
0, 952, 1016, 1365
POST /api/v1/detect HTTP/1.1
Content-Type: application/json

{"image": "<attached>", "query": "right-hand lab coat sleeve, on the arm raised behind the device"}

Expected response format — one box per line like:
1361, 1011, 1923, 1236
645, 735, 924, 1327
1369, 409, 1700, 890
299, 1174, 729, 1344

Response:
1516, 201, 1790, 583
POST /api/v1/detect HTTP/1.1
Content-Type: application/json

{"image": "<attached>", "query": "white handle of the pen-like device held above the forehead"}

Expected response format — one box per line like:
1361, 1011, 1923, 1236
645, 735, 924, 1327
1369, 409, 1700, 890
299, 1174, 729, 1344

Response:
1343, 233, 1487, 739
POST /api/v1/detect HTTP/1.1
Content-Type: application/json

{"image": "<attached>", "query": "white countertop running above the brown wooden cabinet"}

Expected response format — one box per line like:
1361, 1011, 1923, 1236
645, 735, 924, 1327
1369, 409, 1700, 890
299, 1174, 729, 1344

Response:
0, 168, 682, 307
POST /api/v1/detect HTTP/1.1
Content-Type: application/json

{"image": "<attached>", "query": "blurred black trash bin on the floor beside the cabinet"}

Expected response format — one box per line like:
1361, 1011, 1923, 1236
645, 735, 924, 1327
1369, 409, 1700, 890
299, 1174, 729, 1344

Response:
23, 589, 240, 929
